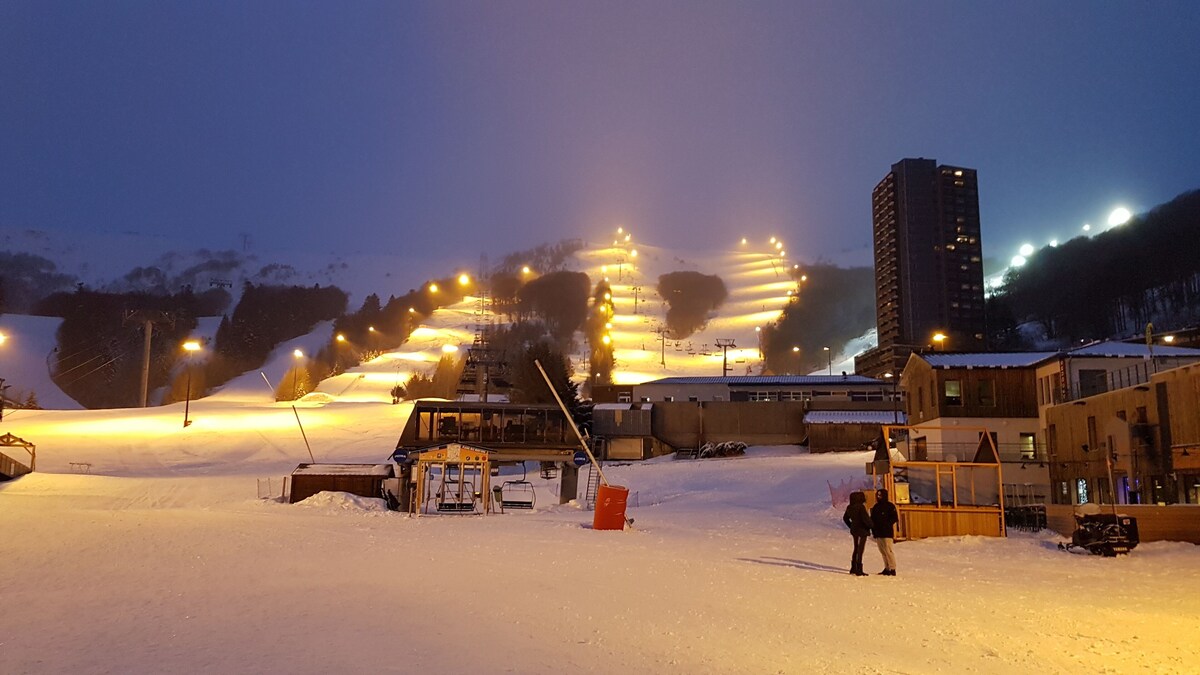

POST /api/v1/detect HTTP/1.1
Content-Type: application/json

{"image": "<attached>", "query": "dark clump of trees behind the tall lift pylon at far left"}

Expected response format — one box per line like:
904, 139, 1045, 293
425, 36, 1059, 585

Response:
32, 283, 229, 408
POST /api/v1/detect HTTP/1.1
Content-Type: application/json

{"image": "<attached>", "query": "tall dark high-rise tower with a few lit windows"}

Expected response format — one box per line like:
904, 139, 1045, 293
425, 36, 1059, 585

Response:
854, 159, 985, 377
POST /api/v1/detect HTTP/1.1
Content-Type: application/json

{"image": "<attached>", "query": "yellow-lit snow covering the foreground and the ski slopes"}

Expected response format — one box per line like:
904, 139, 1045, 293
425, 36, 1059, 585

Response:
0, 239, 1200, 674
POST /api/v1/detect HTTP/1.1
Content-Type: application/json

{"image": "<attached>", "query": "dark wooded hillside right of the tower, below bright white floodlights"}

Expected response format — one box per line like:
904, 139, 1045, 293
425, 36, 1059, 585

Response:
988, 191, 1200, 348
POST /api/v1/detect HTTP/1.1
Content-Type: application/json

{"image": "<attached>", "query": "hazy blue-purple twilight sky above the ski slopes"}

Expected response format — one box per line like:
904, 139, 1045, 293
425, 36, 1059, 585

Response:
0, 0, 1200, 270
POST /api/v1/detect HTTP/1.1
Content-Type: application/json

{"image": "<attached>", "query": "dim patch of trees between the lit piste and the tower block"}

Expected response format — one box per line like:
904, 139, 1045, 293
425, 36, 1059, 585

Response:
762, 264, 875, 374
